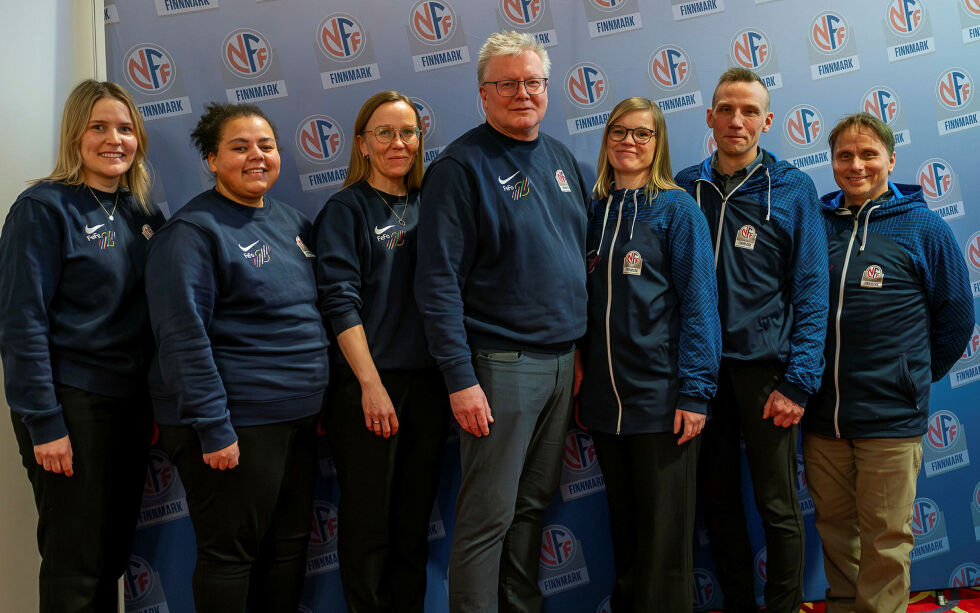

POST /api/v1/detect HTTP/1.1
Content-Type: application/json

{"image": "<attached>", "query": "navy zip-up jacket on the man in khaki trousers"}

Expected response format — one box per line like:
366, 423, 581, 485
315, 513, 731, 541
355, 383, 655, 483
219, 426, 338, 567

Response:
803, 183, 974, 438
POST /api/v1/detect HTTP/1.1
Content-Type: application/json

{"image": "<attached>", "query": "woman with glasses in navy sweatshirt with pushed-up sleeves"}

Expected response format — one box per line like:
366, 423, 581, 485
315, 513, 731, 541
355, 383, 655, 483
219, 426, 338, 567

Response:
314, 91, 449, 613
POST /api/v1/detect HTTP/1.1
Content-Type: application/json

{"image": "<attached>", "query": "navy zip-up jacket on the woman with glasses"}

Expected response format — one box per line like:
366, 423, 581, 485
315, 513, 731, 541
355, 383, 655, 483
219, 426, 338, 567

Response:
579, 189, 721, 434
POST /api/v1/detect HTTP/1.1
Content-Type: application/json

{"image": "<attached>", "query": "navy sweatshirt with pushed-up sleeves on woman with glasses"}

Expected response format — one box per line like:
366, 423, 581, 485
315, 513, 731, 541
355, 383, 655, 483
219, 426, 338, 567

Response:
313, 181, 434, 369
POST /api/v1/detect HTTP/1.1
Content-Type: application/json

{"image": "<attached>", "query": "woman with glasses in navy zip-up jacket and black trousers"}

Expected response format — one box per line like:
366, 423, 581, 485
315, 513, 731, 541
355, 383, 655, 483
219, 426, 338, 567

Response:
579, 98, 721, 613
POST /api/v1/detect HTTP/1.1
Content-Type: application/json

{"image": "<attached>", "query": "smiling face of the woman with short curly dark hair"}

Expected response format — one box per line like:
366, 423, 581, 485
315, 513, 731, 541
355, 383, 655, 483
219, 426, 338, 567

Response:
208, 115, 279, 206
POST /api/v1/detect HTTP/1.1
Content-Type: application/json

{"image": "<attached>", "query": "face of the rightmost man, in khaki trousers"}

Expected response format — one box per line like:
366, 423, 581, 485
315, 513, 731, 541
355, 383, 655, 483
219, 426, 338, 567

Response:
834, 127, 895, 206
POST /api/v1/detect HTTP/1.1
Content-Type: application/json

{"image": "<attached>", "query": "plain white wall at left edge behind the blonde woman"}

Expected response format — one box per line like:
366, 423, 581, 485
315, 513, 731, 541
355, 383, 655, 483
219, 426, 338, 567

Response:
0, 0, 106, 612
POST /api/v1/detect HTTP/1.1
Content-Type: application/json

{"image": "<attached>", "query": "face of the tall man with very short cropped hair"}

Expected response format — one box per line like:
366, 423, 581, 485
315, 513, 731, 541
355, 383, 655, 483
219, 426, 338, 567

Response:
707, 81, 772, 174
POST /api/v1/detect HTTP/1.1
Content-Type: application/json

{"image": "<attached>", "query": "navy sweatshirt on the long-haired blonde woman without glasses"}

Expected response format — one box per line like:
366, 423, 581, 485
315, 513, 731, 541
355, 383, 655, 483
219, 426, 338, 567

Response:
0, 181, 163, 445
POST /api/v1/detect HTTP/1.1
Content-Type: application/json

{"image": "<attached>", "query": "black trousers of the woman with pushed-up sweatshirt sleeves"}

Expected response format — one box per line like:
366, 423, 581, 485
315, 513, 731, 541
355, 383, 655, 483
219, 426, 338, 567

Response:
327, 366, 449, 613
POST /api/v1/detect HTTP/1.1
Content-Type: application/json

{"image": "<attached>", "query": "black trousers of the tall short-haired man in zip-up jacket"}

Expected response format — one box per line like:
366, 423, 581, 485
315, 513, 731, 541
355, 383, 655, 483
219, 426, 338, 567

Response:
698, 360, 804, 613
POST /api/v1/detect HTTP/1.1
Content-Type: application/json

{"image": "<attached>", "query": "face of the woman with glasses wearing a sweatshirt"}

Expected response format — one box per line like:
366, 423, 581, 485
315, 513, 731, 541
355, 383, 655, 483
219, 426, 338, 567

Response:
356, 100, 419, 194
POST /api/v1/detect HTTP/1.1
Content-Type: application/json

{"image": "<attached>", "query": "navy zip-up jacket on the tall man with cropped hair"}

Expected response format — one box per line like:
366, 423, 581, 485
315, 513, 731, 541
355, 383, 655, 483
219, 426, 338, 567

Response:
676, 150, 828, 405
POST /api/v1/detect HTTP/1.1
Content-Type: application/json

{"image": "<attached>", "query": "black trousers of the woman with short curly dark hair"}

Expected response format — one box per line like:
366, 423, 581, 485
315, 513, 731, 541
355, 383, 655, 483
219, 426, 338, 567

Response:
160, 415, 317, 613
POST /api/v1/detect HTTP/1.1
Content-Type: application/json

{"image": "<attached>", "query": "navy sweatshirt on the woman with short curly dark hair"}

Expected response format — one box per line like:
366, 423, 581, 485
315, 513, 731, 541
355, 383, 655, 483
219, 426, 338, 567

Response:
146, 189, 328, 453
